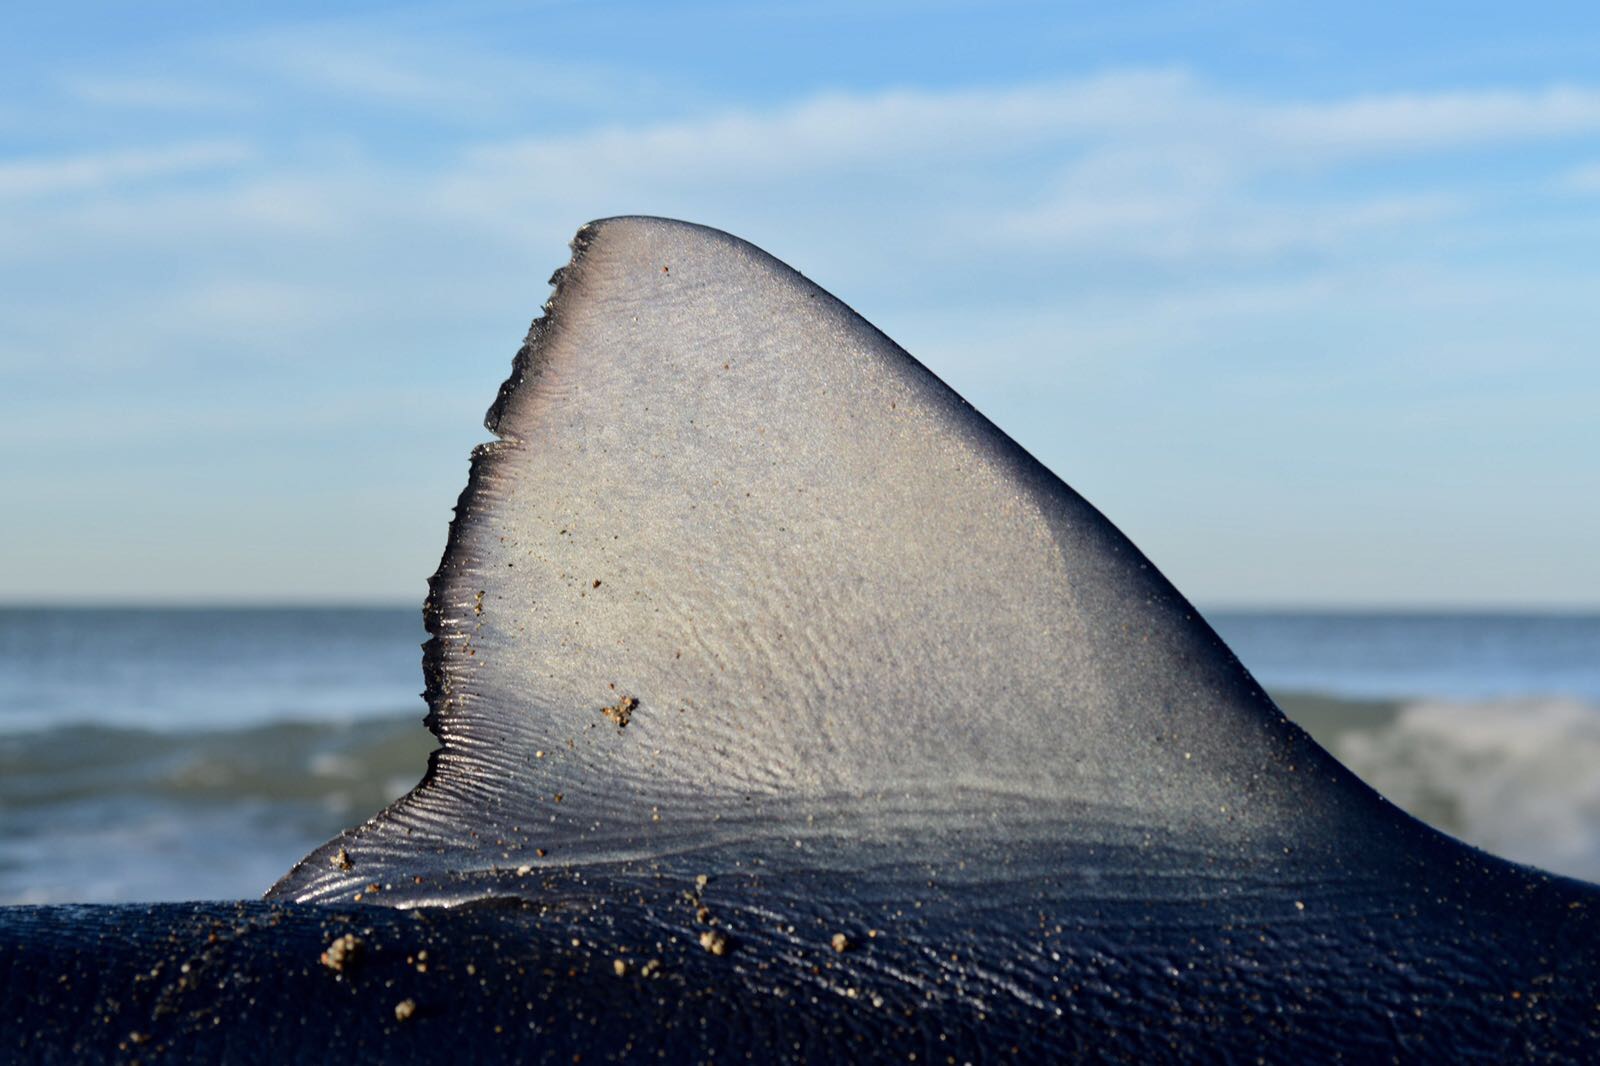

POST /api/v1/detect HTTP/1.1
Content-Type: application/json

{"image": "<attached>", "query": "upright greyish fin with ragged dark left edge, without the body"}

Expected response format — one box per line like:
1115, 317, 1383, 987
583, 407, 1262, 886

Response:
270, 218, 1405, 903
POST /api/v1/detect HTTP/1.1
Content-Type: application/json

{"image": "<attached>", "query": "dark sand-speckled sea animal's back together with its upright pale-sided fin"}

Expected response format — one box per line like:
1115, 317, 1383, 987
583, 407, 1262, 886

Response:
0, 219, 1600, 1061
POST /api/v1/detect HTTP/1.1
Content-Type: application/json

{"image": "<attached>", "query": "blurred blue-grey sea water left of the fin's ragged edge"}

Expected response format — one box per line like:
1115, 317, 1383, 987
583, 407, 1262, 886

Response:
0, 608, 435, 903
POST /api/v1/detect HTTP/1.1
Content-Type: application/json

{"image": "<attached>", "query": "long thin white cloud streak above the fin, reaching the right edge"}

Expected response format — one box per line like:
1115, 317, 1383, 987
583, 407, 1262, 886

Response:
444, 70, 1600, 195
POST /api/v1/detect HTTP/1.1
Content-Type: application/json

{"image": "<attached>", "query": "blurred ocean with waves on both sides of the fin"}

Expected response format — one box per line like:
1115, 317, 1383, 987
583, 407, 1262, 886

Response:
0, 608, 1600, 903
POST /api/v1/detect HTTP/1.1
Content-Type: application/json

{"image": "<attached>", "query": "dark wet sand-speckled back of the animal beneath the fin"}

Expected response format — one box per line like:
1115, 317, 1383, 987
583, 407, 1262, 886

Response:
9, 860, 1600, 1063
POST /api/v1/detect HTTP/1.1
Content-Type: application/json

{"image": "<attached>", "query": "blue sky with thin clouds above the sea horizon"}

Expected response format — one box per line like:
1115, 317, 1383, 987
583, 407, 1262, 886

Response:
0, 2, 1600, 607
